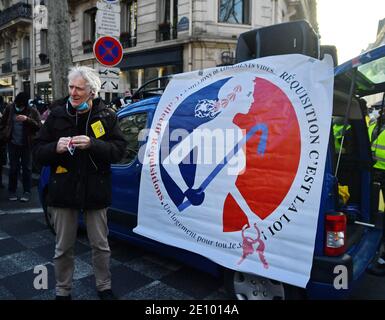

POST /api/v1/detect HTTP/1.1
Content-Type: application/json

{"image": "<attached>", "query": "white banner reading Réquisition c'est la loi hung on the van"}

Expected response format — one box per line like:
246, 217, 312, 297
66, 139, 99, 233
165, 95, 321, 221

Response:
134, 55, 333, 287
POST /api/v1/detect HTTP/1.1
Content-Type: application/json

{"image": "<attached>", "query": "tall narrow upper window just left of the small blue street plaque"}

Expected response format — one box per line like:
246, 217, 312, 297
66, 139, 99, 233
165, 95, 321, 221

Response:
157, 0, 178, 41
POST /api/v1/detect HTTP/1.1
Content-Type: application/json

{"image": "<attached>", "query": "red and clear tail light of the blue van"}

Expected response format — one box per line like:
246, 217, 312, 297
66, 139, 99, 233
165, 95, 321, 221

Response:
325, 212, 346, 257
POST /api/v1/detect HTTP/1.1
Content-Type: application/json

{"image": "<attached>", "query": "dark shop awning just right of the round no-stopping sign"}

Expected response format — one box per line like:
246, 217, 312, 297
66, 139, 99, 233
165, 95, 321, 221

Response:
117, 46, 183, 70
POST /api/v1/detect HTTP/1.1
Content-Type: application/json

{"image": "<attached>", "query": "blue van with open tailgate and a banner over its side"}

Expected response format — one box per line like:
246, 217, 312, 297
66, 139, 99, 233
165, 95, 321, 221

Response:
39, 33, 385, 300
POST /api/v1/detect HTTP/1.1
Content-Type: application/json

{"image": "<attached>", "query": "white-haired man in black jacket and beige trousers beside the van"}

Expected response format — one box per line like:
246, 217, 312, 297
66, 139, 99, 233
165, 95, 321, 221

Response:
34, 66, 126, 300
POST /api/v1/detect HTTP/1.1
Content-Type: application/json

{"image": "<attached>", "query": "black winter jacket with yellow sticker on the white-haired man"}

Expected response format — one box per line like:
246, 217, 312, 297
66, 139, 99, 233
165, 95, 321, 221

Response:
33, 99, 126, 209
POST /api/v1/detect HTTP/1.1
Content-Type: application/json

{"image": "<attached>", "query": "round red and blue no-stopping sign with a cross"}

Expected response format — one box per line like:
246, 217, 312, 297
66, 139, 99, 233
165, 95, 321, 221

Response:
94, 36, 123, 67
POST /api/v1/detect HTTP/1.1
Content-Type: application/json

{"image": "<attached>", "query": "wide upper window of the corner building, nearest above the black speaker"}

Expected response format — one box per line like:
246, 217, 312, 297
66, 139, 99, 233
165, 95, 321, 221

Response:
218, 0, 250, 24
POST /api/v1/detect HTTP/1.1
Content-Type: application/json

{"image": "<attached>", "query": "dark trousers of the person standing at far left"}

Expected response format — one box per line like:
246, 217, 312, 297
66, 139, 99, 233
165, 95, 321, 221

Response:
8, 143, 32, 193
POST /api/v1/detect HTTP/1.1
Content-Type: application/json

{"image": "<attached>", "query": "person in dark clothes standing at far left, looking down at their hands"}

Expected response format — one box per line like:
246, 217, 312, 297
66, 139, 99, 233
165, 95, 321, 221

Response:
0, 92, 41, 202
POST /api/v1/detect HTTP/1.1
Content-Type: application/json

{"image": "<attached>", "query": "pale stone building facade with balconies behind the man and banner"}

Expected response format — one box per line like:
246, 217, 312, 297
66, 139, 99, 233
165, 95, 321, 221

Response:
0, 0, 318, 101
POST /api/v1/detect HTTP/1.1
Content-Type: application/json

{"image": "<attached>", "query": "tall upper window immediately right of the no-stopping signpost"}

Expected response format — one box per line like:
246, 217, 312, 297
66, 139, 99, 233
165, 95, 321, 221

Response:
120, 0, 138, 48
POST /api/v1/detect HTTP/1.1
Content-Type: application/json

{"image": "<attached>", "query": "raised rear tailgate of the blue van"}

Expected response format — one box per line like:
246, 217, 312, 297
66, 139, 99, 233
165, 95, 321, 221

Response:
334, 45, 385, 97
